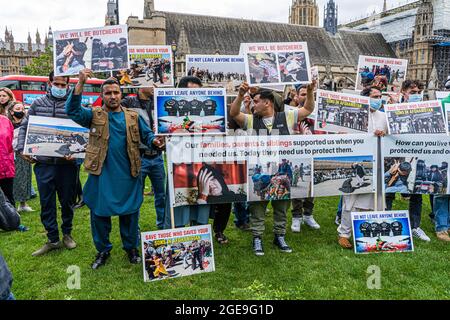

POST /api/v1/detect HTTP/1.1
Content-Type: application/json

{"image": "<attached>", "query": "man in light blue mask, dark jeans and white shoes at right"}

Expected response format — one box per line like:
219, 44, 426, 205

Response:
386, 80, 431, 242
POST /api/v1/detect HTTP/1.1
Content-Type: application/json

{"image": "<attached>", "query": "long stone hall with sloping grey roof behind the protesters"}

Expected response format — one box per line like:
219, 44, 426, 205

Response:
127, 0, 395, 90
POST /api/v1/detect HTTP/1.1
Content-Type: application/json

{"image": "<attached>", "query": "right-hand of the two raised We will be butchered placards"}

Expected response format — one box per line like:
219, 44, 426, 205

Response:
241, 42, 312, 85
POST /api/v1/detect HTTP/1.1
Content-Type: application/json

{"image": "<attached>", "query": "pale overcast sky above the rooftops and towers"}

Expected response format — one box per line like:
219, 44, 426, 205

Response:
0, 0, 414, 42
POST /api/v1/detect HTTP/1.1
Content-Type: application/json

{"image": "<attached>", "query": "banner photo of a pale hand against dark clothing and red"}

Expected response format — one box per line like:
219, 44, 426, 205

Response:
173, 162, 247, 207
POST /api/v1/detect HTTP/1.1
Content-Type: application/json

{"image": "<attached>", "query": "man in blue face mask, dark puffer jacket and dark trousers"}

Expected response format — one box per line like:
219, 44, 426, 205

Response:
17, 72, 78, 256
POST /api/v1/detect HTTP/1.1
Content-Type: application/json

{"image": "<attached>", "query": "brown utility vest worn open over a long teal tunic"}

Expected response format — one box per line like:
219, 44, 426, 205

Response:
84, 107, 141, 178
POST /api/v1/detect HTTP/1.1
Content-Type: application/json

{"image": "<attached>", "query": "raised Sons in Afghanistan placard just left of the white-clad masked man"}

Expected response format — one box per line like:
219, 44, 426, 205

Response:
315, 90, 370, 133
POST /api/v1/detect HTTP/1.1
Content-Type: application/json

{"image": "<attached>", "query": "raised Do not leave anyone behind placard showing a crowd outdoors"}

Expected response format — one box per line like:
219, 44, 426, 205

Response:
186, 55, 246, 96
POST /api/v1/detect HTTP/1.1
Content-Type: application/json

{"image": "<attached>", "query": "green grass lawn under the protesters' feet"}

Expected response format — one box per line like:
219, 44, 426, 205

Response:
0, 170, 450, 300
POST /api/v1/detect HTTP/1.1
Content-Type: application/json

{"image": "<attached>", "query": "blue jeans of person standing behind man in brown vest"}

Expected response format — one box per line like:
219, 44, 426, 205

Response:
141, 155, 166, 230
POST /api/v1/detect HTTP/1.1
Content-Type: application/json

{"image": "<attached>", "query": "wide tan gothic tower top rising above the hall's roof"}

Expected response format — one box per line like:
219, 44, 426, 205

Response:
289, 0, 319, 27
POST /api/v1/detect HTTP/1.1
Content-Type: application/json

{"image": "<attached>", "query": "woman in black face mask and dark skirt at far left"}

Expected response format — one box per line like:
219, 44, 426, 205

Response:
7, 102, 34, 212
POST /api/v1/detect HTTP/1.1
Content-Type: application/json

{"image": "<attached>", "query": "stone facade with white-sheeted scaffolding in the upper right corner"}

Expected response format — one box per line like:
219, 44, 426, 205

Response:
340, 0, 450, 90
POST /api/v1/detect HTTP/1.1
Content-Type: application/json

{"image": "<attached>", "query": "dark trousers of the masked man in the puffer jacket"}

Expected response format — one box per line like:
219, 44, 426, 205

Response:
34, 163, 78, 243
